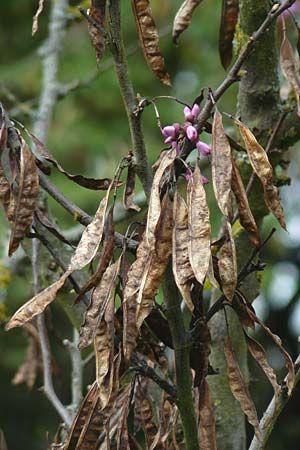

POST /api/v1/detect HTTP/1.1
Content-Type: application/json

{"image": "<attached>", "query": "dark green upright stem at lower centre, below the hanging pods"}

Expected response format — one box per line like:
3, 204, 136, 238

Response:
163, 261, 199, 450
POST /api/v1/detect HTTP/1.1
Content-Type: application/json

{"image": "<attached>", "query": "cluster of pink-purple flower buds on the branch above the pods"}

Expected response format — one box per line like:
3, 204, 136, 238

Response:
161, 103, 211, 184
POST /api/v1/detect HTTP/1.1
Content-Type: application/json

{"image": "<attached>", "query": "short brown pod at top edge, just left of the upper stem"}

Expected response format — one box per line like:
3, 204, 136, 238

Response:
87, 0, 106, 62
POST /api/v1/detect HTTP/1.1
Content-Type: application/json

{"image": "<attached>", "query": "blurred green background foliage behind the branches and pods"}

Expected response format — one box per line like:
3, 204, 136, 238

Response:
0, 0, 300, 450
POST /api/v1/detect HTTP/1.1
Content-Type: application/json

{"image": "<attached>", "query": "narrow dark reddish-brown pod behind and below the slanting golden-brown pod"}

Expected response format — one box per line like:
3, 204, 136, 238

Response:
231, 158, 260, 247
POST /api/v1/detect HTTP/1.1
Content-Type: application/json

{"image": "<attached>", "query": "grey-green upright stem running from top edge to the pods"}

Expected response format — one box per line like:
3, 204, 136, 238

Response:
108, 0, 152, 198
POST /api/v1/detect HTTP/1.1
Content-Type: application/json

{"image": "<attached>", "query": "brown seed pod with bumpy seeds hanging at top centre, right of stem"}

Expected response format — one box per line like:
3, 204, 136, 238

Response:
131, 0, 171, 86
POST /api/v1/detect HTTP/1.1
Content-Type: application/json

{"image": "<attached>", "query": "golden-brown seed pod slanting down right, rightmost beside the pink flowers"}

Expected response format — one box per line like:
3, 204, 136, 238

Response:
236, 120, 286, 229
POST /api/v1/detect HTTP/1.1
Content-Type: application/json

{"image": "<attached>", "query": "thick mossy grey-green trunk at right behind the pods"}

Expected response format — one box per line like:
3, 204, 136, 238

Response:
209, 0, 279, 450
